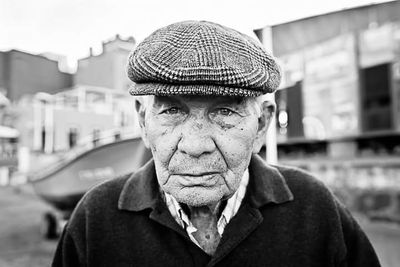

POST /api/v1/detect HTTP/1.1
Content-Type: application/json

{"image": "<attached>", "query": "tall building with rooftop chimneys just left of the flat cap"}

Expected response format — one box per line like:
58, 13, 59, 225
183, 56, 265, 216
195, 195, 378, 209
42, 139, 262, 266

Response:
74, 34, 136, 92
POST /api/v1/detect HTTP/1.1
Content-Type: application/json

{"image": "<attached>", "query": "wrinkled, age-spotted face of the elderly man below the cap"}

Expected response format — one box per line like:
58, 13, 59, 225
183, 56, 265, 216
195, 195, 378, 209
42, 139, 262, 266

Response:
137, 96, 268, 206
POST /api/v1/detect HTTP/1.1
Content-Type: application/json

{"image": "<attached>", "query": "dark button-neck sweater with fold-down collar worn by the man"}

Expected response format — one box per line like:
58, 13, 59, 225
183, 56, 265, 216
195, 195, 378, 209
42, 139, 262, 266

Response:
53, 156, 380, 267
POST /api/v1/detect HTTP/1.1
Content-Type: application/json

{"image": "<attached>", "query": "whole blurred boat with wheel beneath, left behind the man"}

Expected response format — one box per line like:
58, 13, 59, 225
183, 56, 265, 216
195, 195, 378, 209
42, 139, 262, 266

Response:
28, 130, 151, 238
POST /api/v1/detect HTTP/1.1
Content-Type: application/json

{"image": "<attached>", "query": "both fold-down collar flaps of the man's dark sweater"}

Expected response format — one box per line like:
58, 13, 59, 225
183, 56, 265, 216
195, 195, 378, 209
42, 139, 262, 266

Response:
118, 155, 293, 211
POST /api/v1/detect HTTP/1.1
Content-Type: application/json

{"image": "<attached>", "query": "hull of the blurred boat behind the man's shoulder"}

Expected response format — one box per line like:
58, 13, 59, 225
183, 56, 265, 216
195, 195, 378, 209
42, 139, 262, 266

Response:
31, 138, 151, 211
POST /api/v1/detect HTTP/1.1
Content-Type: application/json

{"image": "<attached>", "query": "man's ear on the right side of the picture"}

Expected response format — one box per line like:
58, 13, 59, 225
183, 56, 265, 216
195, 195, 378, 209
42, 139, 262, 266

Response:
253, 100, 276, 153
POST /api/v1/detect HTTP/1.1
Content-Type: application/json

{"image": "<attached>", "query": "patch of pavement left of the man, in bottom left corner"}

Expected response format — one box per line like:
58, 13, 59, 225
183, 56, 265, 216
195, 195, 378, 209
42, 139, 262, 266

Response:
0, 186, 57, 267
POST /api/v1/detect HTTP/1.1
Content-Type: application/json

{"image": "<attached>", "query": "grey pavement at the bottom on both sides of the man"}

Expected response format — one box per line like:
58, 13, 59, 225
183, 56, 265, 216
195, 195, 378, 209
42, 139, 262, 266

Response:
0, 185, 400, 267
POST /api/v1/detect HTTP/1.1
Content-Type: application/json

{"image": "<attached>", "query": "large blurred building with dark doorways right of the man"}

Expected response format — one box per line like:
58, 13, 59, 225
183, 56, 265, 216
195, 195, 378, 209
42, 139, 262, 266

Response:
255, 1, 400, 198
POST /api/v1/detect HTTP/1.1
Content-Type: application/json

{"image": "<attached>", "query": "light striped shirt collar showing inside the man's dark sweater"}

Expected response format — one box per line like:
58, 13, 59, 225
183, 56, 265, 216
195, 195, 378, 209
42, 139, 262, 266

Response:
164, 169, 249, 248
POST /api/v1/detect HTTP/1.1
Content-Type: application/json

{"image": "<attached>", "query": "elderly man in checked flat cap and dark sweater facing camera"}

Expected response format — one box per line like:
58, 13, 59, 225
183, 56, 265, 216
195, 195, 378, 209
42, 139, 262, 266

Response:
53, 21, 379, 266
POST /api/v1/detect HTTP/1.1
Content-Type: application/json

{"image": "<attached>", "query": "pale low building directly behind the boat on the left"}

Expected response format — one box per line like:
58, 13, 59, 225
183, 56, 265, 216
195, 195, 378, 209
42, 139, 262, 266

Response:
16, 85, 139, 154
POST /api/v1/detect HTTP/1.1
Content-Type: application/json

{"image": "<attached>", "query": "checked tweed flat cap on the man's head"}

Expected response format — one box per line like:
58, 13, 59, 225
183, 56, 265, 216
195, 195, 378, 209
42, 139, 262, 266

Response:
127, 21, 281, 97
